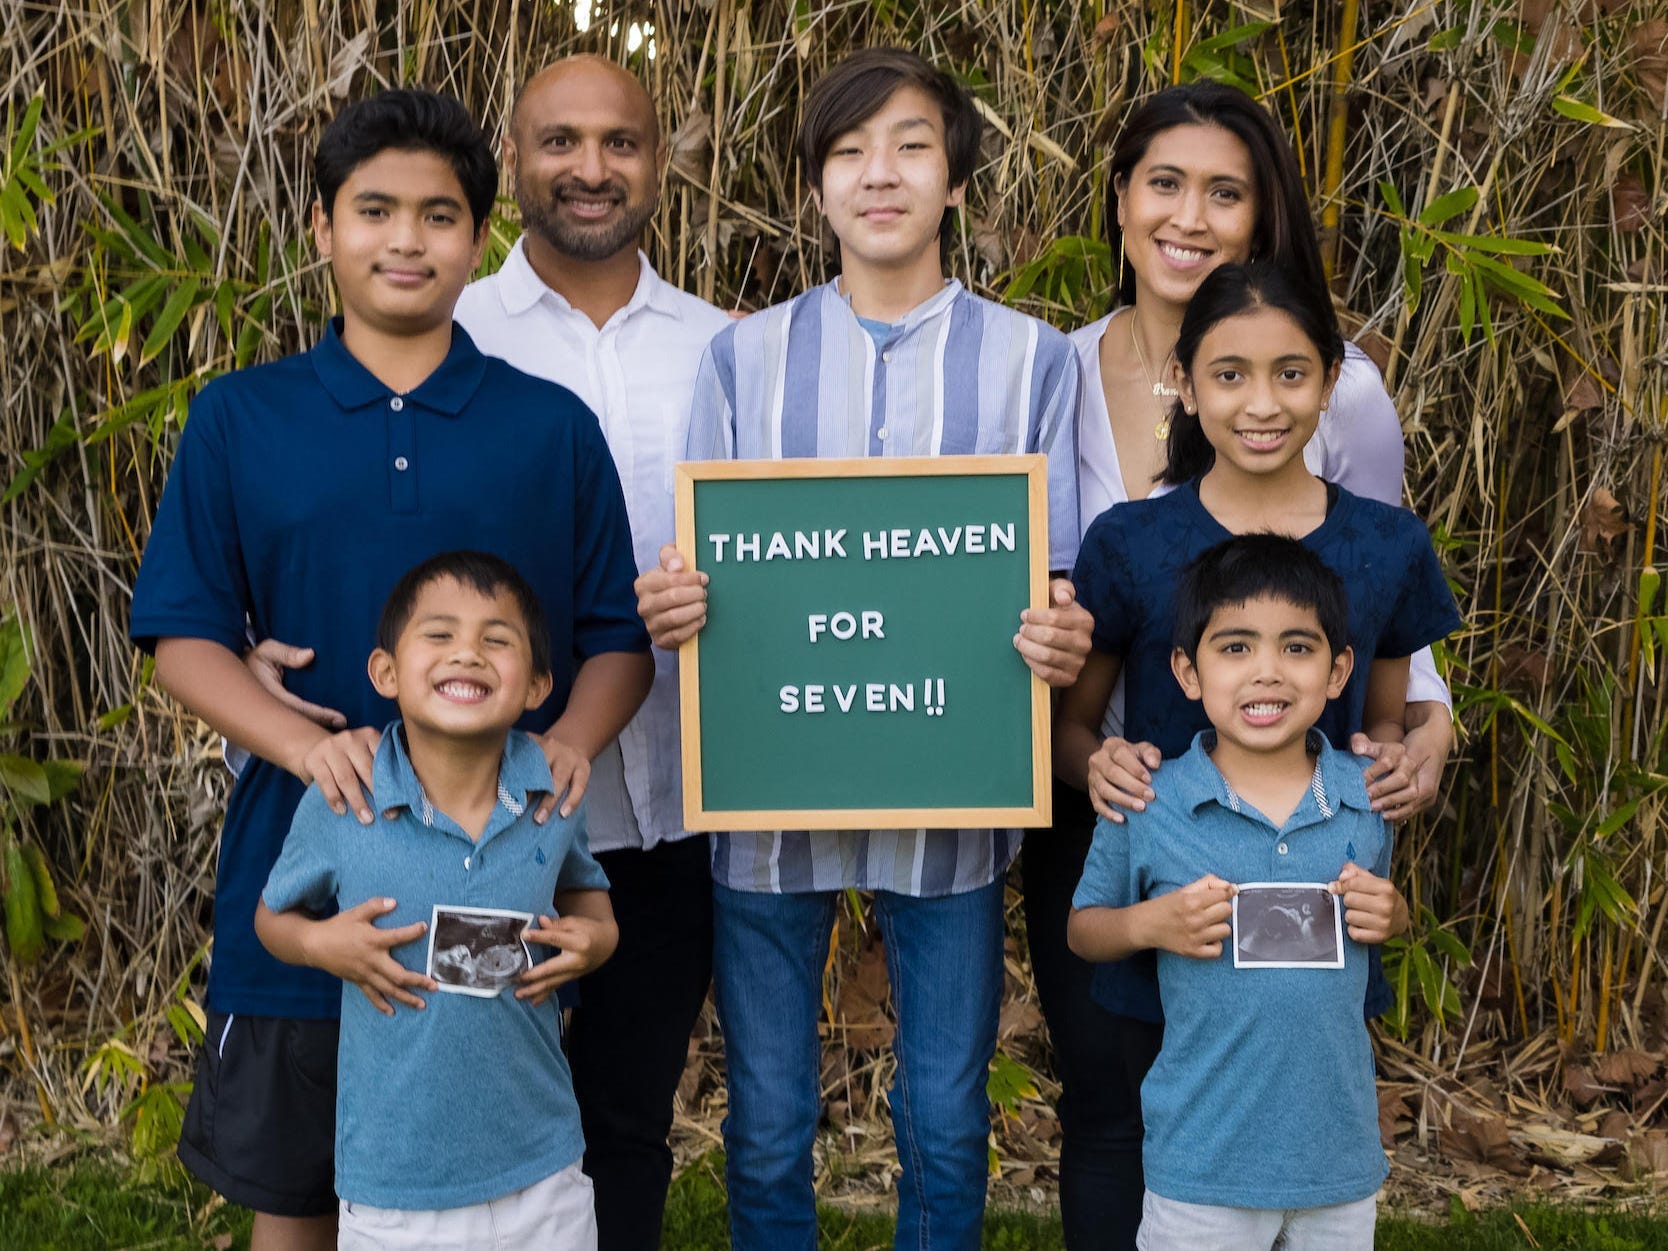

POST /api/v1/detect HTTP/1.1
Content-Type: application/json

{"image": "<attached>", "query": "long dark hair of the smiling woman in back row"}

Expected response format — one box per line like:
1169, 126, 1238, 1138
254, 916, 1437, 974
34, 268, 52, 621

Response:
1106, 80, 1326, 304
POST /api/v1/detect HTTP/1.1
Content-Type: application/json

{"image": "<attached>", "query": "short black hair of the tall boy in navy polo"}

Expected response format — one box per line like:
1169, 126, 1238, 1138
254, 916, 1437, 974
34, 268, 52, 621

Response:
314, 87, 499, 235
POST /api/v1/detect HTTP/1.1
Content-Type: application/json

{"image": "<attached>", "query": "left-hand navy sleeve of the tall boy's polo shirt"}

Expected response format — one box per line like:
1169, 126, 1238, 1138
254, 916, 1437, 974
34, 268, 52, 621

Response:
128, 385, 250, 652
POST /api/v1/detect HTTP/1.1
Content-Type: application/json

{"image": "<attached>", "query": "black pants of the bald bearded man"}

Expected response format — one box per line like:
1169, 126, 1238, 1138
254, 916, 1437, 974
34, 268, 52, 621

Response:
567, 836, 712, 1251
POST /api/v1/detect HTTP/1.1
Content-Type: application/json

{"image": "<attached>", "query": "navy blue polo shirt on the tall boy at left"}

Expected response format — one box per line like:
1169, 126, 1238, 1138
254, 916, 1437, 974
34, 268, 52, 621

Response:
128, 324, 649, 1019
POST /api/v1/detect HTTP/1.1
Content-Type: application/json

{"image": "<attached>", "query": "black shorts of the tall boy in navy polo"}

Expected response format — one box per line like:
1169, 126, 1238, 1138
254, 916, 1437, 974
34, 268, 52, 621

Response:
180, 1012, 340, 1216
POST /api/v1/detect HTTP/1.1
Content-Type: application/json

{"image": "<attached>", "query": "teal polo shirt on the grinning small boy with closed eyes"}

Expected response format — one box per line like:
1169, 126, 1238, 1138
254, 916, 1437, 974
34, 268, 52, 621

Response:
264, 722, 609, 1211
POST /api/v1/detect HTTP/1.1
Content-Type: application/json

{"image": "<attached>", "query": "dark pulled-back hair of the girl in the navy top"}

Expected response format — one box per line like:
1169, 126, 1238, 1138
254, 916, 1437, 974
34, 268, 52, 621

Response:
1158, 260, 1344, 485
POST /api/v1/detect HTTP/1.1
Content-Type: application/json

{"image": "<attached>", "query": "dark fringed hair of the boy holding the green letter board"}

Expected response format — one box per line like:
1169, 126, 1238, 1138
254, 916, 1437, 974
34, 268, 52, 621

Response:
796, 48, 984, 240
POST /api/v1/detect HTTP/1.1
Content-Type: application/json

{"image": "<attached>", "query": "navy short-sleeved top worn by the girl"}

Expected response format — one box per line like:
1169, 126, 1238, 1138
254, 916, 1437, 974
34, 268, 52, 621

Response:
1071, 482, 1460, 1021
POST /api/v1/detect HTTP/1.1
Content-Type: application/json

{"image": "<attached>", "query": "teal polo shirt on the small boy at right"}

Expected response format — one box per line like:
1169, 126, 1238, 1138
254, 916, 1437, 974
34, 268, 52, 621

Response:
1071, 731, 1391, 1208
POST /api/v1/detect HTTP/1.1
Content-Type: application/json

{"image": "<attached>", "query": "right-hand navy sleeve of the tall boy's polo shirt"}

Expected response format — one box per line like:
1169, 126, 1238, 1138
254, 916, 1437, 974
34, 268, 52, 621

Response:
574, 414, 649, 659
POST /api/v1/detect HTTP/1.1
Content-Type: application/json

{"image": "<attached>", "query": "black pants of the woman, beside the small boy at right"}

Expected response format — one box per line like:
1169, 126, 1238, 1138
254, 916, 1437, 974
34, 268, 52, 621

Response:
1019, 782, 1164, 1251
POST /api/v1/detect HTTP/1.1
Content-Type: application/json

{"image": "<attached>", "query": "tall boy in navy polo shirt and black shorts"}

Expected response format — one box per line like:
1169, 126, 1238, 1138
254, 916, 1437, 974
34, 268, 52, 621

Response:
130, 90, 652, 1251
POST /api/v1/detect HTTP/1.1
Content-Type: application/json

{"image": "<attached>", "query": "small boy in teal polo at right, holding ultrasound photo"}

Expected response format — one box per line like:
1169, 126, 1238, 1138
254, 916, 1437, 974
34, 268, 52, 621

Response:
1068, 534, 1398, 1251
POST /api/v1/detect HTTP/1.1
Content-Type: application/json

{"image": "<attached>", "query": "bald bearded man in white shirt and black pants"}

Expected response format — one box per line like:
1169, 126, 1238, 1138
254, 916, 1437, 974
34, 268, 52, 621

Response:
249, 57, 729, 1251
